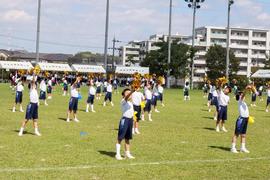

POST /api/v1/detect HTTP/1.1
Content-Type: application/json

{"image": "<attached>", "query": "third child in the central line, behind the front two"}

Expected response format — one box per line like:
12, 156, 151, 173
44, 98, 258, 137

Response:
142, 83, 153, 121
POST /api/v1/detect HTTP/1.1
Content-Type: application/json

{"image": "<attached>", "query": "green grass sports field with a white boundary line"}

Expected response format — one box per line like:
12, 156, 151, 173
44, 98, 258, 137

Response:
0, 84, 270, 179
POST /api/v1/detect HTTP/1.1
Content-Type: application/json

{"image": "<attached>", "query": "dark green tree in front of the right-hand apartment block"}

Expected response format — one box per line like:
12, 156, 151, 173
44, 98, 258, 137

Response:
205, 45, 240, 80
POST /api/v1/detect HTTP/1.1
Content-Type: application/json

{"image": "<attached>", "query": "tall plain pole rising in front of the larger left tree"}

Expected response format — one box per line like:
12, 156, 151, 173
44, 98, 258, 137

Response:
167, 0, 173, 88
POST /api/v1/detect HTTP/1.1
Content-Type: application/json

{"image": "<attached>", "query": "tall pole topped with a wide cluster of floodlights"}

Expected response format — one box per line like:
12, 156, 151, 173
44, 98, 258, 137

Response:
185, 0, 205, 89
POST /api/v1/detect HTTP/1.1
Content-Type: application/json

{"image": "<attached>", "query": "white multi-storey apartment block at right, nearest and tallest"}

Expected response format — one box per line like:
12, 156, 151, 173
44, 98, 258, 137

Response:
194, 26, 270, 81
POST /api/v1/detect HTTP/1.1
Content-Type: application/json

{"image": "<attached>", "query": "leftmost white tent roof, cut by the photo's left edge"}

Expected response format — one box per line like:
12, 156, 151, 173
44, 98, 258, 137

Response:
0, 61, 33, 70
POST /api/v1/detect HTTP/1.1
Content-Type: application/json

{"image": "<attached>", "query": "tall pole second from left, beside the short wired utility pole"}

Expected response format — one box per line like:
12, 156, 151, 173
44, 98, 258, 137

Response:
104, 0, 110, 74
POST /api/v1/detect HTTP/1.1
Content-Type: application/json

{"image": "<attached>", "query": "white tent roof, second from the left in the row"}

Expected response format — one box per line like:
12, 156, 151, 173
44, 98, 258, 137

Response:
38, 63, 72, 72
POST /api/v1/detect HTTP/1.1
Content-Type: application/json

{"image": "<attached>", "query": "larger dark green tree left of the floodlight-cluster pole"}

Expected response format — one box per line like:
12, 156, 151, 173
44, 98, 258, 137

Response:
140, 41, 190, 78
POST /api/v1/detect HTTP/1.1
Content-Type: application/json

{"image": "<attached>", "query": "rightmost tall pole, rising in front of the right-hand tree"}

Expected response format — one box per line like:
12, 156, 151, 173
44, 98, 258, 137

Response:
226, 0, 234, 79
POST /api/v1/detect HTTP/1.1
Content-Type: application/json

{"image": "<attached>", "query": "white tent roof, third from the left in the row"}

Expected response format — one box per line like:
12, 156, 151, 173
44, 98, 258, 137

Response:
71, 64, 106, 73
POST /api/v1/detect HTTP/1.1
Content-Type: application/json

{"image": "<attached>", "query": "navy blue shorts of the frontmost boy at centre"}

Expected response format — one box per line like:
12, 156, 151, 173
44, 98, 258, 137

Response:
118, 117, 133, 141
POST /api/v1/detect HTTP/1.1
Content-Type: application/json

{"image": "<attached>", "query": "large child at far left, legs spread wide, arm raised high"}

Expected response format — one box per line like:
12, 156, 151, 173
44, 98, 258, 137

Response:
18, 77, 41, 136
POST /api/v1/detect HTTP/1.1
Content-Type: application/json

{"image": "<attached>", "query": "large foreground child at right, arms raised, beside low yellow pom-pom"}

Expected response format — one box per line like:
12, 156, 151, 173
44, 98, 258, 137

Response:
231, 92, 249, 153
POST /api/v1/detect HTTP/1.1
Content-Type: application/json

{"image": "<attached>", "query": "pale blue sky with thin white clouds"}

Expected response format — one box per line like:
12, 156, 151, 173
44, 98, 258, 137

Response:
0, 0, 270, 54
